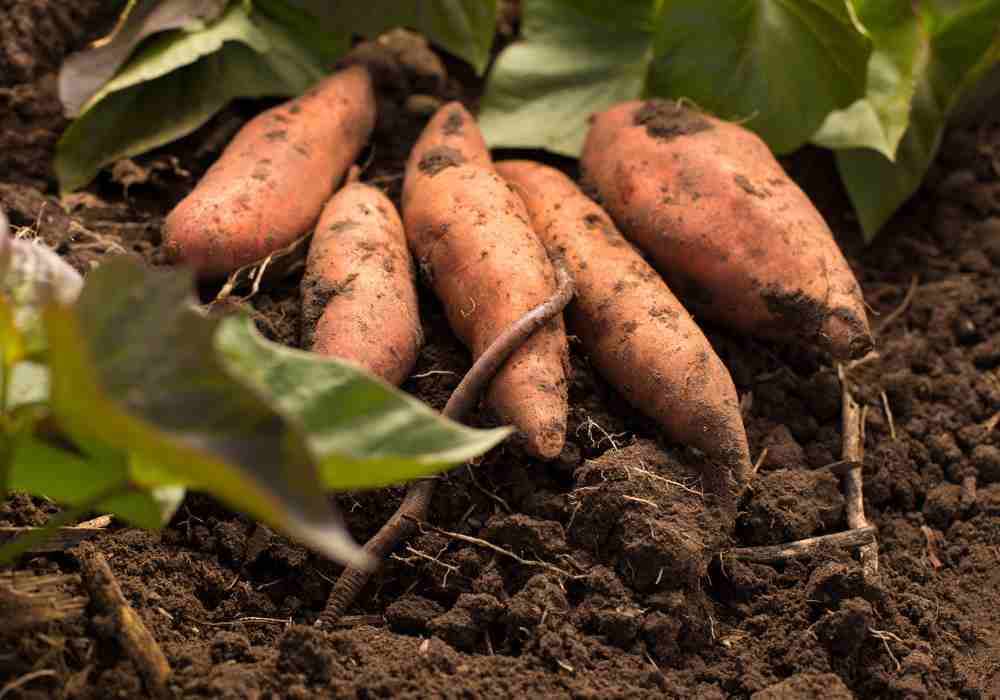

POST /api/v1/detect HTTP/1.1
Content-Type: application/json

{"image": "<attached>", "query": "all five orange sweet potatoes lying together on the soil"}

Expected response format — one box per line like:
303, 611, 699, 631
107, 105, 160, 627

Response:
164, 66, 872, 504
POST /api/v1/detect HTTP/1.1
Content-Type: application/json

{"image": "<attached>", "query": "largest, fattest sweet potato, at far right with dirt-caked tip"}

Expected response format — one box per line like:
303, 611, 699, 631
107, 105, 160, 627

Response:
581, 100, 872, 360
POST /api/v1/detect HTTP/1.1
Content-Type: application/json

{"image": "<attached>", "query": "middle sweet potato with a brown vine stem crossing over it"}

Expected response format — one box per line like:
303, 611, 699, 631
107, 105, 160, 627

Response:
403, 102, 567, 459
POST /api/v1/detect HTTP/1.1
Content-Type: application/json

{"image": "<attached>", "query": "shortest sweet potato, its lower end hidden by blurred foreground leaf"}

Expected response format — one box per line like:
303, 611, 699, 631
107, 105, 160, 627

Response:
301, 182, 423, 385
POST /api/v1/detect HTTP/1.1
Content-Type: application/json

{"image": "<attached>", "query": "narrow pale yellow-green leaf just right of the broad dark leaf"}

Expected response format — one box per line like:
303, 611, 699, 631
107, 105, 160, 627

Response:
812, 0, 927, 160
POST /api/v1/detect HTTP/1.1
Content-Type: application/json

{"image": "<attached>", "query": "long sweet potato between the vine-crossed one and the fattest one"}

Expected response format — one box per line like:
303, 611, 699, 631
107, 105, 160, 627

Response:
496, 161, 751, 488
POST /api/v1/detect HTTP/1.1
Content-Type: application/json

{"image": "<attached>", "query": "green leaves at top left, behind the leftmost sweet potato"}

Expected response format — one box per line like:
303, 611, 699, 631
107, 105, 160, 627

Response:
55, 0, 496, 193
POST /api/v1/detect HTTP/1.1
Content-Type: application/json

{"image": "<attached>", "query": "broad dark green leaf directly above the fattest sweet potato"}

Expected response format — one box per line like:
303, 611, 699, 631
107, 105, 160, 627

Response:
646, 0, 869, 153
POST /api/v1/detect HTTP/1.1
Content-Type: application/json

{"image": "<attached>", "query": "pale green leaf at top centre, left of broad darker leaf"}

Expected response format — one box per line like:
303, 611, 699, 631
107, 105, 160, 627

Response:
479, 0, 655, 156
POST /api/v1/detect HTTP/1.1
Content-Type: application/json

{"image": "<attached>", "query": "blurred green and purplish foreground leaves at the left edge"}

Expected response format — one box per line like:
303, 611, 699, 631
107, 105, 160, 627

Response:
0, 259, 509, 565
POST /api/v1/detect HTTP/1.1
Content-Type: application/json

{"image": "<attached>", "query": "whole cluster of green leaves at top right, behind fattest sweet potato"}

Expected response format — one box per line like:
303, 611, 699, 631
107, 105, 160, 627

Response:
480, 0, 1000, 239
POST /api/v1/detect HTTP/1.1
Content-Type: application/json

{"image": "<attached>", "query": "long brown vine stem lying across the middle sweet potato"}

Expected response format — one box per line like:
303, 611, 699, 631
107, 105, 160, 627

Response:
316, 260, 573, 628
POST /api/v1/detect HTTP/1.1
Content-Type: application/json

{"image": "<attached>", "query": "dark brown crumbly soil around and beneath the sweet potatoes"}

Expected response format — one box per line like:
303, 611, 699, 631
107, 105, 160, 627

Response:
0, 5, 1000, 700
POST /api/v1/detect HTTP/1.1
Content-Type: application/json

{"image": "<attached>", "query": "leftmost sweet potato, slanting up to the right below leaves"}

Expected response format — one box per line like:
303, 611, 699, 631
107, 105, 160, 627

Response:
163, 66, 375, 278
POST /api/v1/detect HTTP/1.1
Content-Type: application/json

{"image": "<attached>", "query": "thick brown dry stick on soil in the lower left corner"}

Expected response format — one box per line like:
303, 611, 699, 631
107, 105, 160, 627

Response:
78, 543, 171, 698
